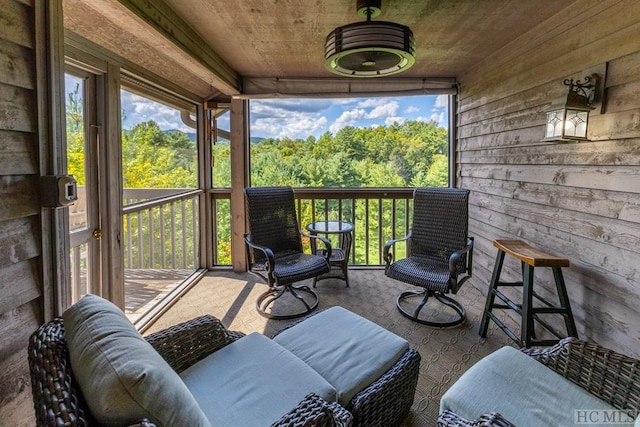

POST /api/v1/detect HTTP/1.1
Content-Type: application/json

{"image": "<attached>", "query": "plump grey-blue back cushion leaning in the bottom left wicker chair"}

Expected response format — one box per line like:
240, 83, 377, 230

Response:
62, 295, 210, 426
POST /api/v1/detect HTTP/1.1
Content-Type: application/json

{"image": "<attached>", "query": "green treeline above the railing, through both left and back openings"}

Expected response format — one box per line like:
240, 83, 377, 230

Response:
67, 113, 448, 188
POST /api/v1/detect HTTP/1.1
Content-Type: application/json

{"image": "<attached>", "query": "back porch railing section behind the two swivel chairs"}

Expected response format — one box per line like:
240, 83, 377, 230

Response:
210, 188, 413, 266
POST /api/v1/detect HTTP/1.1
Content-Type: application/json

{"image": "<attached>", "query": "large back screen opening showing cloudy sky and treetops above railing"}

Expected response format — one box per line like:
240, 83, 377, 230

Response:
250, 95, 449, 187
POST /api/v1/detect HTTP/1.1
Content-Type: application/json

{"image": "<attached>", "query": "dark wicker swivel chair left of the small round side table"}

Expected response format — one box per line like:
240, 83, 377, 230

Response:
244, 187, 331, 319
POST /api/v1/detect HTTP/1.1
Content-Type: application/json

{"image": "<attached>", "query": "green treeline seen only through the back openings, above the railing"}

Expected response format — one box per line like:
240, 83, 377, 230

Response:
213, 121, 448, 187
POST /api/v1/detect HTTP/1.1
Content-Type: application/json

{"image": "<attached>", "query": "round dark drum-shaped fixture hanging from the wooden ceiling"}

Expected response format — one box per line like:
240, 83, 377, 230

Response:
324, 0, 416, 77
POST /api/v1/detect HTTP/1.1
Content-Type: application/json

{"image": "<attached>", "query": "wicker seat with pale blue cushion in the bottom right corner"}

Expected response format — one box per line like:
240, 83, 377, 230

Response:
438, 337, 640, 427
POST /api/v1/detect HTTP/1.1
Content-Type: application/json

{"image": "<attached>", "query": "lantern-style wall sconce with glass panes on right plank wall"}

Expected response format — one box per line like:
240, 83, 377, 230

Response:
545, 74, 601, 141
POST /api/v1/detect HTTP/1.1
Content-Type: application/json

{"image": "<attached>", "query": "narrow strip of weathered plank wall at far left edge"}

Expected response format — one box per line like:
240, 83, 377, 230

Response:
0, 0, 43, 426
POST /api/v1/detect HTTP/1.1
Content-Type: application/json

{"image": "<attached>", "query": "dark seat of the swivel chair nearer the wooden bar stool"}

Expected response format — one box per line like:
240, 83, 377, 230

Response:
385, 256, 451, 292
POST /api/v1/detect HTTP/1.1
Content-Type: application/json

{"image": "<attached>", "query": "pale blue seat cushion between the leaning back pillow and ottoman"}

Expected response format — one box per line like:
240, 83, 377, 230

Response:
180, 332, 336, 427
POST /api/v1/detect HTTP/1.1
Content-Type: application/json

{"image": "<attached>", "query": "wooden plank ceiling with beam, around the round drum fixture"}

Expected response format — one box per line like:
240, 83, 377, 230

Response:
63, 0, 571, 98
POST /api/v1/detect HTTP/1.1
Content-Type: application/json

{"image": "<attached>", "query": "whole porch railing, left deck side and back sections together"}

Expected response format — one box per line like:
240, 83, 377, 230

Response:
123, 188, 413, 269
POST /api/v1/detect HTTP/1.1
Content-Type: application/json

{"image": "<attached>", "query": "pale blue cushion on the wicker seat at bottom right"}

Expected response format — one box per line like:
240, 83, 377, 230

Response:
440, 347, 614, 427
